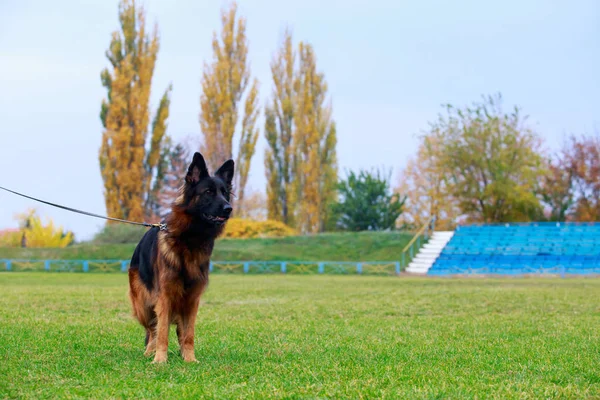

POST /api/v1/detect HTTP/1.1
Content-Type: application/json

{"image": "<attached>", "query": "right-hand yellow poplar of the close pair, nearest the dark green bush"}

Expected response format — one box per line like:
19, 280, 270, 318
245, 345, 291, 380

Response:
293, 42, 337, 233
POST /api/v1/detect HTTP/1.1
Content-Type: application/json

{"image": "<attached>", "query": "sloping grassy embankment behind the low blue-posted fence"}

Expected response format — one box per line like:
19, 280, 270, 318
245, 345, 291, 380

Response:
0, 232, 412, 261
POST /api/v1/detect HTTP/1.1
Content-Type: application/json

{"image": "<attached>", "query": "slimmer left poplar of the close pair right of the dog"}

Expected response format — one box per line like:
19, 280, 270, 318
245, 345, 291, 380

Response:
265, 30, 296, 226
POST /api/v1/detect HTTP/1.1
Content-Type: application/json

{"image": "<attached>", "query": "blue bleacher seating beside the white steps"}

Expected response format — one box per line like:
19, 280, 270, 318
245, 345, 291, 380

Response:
428, 222, 600, 275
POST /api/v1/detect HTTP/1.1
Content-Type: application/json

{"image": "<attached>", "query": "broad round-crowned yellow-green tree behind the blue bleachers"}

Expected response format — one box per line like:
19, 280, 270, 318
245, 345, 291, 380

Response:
426, 95, 546, 223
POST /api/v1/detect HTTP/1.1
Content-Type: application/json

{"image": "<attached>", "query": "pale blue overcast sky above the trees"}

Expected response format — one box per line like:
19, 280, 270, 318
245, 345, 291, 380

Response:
0, 0, 600, 240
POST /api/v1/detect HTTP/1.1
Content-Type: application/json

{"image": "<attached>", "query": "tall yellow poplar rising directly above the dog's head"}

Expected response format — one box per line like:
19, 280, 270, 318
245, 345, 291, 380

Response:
200, 3, 259, 209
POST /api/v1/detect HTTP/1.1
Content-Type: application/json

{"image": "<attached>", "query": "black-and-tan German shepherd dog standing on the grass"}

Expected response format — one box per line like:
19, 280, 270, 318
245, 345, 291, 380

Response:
129, 153, 234, 363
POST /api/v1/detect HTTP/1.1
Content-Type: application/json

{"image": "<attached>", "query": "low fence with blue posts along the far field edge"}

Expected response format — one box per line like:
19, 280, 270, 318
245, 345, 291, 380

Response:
0, 259, 400, 275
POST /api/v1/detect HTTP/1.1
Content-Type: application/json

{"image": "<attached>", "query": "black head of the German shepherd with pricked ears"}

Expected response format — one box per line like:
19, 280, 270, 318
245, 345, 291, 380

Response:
177, 152, 234, 226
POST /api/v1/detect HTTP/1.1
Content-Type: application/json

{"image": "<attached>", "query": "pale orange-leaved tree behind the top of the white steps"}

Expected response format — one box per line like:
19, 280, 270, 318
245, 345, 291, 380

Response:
396, 136, 460, 230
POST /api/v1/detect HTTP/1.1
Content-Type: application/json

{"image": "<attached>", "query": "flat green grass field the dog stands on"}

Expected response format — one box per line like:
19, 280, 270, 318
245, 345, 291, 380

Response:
0, 273, 600, 399
